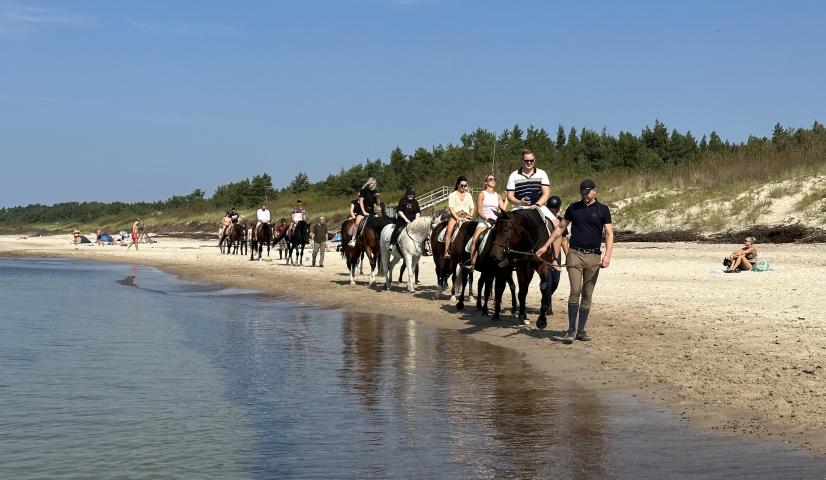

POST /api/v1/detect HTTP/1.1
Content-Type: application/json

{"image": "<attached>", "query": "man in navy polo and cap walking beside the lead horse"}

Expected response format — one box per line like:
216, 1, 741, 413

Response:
536, 178, 614, 344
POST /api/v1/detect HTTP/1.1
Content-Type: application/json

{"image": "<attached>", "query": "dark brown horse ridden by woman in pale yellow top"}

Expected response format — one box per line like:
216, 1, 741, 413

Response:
430, 221, 479, 310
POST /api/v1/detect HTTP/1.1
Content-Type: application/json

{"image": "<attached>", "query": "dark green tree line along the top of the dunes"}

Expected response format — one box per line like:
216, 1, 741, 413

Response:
0, 120, 826, 225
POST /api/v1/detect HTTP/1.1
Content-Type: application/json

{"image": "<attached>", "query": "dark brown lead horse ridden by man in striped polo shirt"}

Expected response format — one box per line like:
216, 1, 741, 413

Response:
487, 209, 555, 328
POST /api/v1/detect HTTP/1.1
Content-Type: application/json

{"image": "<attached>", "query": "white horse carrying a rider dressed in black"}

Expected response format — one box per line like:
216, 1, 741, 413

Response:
380, 217, 433, 293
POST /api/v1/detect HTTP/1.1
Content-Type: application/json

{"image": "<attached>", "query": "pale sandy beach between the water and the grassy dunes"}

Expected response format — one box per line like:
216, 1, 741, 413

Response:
0, 235, 826, 454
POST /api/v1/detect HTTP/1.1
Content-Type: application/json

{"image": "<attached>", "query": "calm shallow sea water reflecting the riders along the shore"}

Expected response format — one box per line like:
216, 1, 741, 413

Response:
0, 259, 826, 479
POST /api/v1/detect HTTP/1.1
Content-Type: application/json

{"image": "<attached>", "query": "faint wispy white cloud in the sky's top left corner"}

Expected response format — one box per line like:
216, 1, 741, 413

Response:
0, 1, 95, 37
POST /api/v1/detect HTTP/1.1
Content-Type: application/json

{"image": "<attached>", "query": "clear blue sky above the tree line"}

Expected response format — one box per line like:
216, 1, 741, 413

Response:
0, 0, 826, 206
